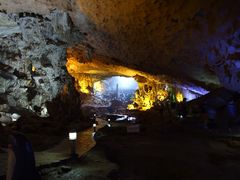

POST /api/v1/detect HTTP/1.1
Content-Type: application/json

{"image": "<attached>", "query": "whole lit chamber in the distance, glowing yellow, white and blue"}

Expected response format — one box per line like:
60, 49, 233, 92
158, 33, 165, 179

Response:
66, 49, 208, 111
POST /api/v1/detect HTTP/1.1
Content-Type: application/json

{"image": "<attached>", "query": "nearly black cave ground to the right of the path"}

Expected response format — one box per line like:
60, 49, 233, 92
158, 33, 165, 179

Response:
97, 113, 240, 180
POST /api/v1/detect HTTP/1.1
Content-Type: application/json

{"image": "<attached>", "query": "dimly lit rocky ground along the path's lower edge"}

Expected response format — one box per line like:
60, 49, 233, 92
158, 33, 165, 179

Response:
40, 147, 118, 180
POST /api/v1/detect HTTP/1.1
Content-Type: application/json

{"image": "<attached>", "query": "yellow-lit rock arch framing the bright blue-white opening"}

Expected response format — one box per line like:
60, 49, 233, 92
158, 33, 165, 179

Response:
66, 48, 183, 111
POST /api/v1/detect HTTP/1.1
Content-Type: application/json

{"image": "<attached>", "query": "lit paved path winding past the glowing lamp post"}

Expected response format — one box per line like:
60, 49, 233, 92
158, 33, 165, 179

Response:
0, 118, 107, 175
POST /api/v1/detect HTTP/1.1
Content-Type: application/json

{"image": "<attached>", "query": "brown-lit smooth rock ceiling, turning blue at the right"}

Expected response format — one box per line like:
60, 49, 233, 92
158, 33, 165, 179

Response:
0, 0, 240, 91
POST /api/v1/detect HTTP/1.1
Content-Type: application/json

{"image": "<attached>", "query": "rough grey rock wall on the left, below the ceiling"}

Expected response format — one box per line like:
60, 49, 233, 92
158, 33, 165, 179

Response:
0, 10, 81, 114
